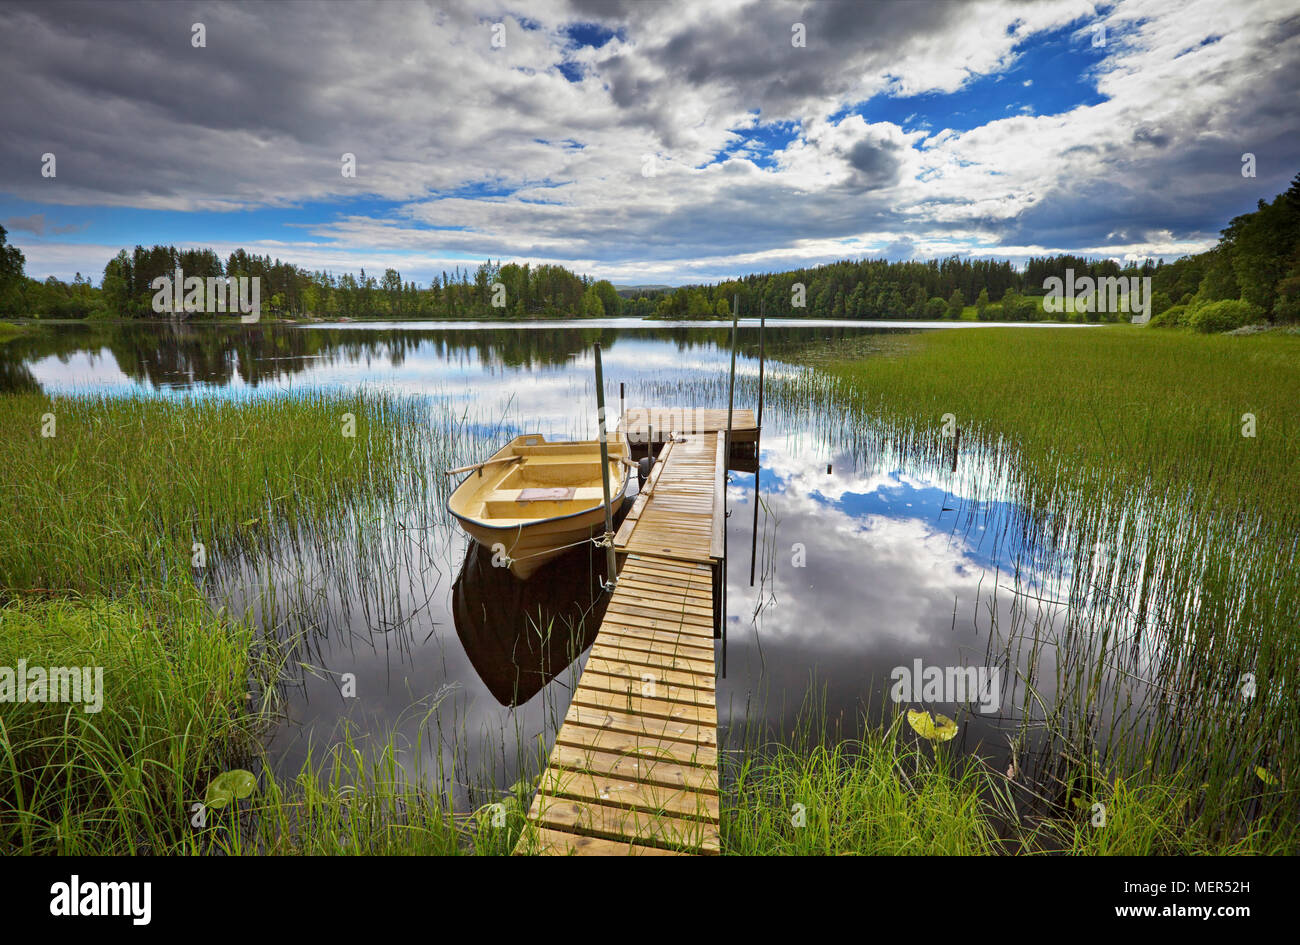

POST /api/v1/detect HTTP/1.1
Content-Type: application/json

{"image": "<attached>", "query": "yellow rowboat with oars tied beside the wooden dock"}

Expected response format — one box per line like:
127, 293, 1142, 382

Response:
447, 434, 631, 581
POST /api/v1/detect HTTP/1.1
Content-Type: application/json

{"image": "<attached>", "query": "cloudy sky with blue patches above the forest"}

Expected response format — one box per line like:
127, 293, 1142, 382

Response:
0, 0, 1300, 285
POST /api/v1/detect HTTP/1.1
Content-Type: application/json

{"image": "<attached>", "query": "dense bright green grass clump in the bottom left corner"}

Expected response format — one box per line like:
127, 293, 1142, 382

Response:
0, 591, 255, 854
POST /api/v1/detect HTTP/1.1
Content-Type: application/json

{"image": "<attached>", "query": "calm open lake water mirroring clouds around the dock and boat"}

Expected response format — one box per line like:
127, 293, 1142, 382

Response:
0, 321, 1092, 803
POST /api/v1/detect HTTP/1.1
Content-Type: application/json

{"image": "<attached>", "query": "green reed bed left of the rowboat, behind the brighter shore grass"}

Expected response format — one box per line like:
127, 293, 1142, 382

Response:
0, 394, 426, 594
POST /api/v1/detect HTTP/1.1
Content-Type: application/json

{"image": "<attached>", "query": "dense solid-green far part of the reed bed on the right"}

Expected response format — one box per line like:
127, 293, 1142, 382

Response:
780, 325, 1300, 517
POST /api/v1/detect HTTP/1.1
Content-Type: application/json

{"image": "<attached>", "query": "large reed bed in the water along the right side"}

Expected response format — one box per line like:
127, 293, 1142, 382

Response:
771, 326, 1300, 851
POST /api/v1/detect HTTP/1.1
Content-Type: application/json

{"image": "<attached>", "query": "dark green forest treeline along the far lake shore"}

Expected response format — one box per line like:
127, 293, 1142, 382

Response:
0, 174, 1300, 324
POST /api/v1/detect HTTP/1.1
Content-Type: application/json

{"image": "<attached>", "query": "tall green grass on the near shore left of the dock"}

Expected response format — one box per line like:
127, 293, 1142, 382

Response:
0, 593, 523, 855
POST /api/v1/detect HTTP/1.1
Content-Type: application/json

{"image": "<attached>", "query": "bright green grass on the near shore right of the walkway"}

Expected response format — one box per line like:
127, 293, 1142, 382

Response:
723, 718, 1288, 857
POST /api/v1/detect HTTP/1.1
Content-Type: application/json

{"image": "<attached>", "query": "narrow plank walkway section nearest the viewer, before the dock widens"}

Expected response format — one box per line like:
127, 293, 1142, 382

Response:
516, 555, 720, 854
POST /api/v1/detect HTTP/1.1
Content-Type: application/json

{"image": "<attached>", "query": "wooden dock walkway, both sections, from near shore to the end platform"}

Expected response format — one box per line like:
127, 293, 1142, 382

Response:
516, 426, 733, 855
